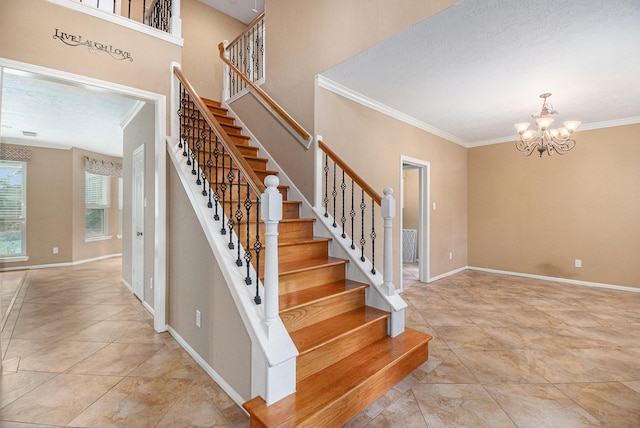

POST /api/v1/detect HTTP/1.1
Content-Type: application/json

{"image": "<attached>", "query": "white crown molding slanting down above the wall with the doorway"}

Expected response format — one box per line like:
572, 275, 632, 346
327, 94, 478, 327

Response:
316, 74, 469, 148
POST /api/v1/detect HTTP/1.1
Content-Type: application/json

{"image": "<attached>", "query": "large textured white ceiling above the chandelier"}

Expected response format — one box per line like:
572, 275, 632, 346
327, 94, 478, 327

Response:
321, 0, 640, 147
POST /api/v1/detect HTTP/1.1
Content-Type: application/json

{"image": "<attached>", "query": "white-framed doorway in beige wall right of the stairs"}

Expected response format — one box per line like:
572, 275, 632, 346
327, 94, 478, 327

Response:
399, 156, 430, 291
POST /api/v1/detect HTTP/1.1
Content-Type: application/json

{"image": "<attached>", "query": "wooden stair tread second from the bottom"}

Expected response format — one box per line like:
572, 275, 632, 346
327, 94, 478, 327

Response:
289, 306, 389, 354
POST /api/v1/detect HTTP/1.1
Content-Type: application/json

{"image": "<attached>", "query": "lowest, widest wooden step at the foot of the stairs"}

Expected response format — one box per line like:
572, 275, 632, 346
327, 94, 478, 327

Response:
243, 328, 431, 427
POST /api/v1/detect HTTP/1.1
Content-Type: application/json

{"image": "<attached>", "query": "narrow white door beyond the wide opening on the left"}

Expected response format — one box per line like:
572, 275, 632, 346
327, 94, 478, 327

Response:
131, 146, 146, 300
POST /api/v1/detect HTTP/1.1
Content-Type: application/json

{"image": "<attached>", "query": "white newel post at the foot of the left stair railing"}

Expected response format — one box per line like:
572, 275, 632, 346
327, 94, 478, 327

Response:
260, 175, 282, 336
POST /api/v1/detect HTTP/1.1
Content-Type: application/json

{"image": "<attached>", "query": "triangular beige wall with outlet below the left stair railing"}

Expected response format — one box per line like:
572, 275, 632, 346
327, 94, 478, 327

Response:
167, 159, 251, 400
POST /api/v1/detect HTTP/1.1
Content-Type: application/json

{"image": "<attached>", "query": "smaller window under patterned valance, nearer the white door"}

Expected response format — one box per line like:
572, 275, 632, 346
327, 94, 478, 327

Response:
84, 172, 111, 238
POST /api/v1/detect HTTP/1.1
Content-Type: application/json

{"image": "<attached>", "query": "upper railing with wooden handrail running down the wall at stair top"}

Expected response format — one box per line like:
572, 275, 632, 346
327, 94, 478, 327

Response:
218, 12, 313, 148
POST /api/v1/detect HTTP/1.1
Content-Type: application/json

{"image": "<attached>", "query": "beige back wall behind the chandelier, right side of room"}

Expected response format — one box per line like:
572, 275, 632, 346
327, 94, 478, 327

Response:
469, 125, 640, 287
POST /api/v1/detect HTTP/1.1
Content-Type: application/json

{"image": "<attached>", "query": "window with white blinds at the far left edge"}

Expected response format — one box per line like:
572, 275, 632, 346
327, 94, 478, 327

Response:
0, 160, 27, 258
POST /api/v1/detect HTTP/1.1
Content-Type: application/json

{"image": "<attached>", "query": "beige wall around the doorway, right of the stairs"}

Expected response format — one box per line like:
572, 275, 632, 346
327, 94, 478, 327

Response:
309, 88, 467, 284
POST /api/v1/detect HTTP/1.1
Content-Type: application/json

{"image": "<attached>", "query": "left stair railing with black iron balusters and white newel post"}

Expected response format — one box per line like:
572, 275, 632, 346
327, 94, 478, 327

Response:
174, 67, 282, 308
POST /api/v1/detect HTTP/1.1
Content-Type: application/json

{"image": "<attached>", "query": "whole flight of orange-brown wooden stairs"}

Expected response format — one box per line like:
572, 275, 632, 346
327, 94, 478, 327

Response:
203, 99, 431, 427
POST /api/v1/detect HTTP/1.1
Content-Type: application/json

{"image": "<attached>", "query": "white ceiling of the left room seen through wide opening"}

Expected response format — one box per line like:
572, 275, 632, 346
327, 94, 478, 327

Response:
0, 69, 141, 156
